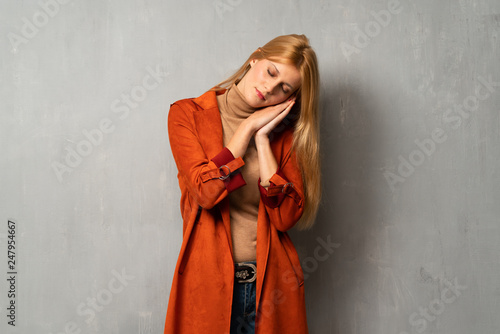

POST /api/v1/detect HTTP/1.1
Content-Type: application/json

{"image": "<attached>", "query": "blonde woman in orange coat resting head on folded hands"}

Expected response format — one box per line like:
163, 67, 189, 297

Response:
165, 35, 320, 334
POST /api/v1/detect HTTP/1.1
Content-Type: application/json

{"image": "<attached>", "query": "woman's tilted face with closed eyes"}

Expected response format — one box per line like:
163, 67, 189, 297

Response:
237, 59, 301, 108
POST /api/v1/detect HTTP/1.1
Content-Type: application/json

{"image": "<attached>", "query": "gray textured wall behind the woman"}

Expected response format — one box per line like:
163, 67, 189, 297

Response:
0, 0, 500, 334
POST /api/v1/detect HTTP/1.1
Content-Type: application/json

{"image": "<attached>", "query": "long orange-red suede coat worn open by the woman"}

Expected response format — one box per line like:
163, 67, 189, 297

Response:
164, 87, 308, 334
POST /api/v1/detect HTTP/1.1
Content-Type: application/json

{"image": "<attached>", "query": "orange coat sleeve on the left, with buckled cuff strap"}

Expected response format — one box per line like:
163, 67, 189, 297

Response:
168, 103, 246, 209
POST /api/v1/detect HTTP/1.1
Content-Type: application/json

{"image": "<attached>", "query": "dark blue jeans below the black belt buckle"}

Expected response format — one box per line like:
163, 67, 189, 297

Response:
231, 261, 256, 334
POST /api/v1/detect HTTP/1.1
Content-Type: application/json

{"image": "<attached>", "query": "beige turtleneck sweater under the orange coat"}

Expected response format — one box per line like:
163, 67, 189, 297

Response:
217, 84, 260, 262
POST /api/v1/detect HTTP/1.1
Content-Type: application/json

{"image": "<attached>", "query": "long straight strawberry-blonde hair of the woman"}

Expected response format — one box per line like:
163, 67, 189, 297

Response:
211, 34, 321, 230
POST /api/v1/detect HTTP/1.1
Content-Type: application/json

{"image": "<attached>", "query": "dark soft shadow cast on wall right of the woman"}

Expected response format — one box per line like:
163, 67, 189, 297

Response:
290, 69, 387, 334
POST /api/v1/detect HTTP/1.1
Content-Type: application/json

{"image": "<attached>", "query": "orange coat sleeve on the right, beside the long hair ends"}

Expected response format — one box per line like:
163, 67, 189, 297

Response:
258, 131, 304, 232
